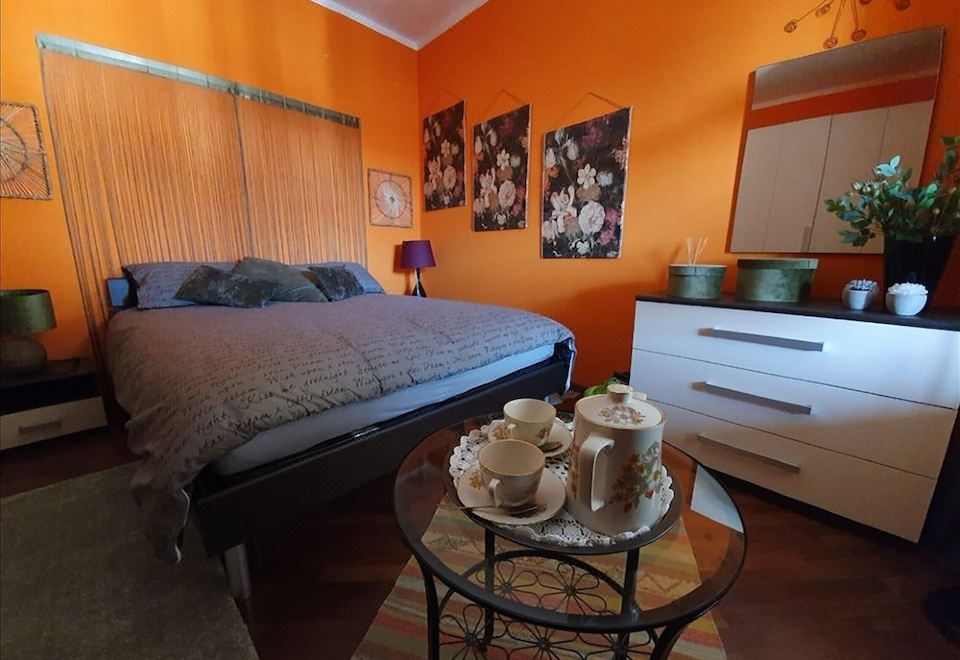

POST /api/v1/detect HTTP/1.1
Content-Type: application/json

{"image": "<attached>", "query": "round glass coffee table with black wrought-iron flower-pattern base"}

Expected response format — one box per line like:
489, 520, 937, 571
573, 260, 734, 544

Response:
394, 415, 746, 659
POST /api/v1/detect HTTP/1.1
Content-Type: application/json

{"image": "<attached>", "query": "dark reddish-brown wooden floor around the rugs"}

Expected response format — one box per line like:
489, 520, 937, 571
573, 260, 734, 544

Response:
0, 428, 960, 660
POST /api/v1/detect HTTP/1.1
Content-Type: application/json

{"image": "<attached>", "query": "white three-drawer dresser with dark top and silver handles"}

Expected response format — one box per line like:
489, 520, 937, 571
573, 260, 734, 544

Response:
630, 295, 960, 541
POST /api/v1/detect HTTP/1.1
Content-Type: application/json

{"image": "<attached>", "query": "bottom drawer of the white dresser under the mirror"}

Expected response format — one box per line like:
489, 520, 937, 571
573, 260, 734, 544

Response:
662, 405, 936, 541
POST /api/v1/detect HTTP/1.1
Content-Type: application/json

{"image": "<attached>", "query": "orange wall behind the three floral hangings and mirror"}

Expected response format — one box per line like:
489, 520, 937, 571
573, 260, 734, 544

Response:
419, 0, 960, 383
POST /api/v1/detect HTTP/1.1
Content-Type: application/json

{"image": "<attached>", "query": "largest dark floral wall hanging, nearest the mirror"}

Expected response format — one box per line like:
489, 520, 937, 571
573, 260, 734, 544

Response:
541, 108, 630, 259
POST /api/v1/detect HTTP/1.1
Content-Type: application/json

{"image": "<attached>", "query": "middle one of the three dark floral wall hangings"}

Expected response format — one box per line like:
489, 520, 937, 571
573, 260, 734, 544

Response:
473, 105, 530, 231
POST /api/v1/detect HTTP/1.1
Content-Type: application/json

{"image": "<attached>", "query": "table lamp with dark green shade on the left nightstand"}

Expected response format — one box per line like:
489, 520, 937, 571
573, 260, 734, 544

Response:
0, 289, 57, 374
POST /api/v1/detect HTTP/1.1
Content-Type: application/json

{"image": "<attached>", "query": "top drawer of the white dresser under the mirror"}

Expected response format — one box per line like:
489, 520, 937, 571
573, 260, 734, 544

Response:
633, 302, 960, 410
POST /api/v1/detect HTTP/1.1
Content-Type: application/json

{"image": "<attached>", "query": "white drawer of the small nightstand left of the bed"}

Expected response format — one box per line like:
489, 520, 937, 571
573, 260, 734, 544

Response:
0, 396, 107, 449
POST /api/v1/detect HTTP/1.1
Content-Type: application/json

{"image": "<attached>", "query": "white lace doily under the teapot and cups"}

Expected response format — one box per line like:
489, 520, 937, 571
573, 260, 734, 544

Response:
450, 422, 673, 546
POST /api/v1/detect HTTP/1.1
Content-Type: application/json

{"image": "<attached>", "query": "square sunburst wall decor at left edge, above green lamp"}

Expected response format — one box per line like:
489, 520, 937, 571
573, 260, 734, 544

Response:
0, 101, 52, 199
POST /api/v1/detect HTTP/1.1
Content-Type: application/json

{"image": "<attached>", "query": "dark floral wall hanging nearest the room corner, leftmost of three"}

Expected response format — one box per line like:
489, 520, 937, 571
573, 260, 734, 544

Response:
423, 101, 466, 211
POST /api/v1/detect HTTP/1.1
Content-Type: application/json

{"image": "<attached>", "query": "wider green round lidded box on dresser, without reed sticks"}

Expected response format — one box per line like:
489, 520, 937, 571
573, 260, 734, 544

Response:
737, 259, 819, 302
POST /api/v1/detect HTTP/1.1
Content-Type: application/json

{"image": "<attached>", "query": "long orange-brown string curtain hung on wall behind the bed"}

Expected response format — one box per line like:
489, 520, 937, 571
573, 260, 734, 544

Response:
41, 49, 366, 363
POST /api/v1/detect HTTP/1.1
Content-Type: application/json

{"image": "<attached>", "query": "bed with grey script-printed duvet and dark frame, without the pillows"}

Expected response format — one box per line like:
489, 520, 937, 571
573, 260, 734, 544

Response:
107, 279, 575, 597
